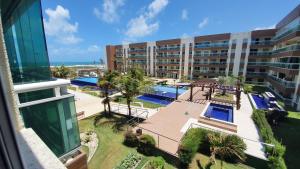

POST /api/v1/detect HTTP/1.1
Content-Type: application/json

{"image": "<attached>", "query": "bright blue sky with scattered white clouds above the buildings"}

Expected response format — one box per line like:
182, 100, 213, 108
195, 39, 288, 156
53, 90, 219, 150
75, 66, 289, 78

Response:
42, 0, 300, 62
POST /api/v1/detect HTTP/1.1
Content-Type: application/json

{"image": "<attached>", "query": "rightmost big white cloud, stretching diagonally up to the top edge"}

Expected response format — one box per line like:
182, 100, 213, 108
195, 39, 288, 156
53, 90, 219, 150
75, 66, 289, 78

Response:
125, 0, 169, 39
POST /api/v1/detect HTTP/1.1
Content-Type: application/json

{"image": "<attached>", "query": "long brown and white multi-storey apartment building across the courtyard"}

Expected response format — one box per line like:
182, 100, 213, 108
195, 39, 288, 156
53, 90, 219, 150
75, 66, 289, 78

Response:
106, 5, 300, 110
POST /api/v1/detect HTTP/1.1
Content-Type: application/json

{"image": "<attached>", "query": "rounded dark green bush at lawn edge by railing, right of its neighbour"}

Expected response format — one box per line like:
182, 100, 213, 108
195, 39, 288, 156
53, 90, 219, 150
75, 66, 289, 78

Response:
138, 134, 155, 155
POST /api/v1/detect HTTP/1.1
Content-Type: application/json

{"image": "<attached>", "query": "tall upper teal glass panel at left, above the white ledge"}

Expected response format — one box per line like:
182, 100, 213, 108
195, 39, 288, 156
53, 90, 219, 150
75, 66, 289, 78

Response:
3, 0, 51, 83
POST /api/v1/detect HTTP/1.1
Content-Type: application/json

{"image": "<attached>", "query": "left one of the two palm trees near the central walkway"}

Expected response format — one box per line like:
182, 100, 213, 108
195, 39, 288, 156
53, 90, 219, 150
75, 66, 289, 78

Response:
98, 71, 119, 114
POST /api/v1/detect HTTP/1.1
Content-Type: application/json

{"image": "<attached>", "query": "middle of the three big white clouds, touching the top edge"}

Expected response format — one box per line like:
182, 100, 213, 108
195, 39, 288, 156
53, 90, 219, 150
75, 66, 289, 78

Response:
93, 0, 124, 23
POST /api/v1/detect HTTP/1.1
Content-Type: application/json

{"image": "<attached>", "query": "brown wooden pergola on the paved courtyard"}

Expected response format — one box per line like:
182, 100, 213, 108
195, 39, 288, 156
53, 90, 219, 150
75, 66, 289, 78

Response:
176, 78, 241, 109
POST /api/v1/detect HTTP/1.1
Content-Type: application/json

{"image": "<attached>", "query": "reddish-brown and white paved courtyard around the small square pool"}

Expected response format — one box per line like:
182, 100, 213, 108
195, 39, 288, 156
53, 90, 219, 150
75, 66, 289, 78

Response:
136, 87, 266, 160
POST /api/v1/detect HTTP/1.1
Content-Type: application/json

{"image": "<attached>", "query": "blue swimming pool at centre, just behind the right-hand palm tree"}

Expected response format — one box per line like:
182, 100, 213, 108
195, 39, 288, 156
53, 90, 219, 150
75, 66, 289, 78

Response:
137, 85, 186, 105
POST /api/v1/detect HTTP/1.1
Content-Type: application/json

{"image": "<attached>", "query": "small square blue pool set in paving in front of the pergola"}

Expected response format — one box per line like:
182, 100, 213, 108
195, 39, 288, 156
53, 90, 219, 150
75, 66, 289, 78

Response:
204, 103, 233, 123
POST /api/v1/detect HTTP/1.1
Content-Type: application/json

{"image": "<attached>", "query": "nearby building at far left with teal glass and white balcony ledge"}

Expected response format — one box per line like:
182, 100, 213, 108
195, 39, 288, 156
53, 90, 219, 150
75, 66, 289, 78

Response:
0, 0, 86, 168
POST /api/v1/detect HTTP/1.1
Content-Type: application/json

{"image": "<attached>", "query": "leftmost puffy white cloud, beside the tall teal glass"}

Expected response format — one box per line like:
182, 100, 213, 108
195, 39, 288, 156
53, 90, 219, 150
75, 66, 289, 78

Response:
44, 5, 82, 44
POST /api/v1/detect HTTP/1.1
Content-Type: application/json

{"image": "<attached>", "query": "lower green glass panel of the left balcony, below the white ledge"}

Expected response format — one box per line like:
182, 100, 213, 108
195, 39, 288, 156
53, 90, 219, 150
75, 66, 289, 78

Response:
20, 97, 80, 157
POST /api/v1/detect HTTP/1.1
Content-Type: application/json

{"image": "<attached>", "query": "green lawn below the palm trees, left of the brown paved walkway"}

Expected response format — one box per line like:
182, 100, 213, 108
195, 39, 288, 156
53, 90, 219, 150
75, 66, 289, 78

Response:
79, 114, 175, 169
